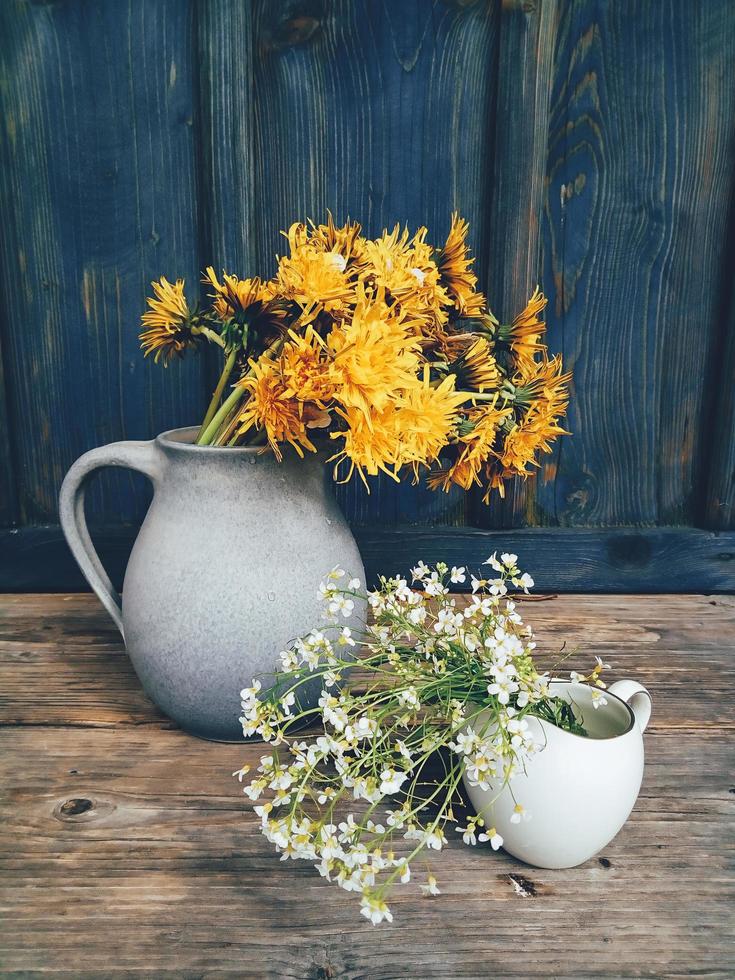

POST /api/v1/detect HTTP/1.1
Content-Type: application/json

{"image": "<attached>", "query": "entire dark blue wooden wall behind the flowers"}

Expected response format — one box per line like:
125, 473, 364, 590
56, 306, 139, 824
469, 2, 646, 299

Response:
0, 0, 735, 589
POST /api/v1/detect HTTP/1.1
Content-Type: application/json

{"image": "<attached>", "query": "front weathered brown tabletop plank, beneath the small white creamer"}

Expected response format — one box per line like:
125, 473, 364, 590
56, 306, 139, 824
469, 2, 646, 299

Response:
0, 727, 733, 980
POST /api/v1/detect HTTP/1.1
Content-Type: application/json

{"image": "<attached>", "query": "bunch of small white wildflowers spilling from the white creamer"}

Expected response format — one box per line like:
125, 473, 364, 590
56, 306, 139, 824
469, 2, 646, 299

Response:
234, 554, 607, 925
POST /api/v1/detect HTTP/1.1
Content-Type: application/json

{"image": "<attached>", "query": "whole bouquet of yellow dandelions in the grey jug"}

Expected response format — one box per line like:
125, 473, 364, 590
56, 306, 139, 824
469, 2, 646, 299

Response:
141, 215, 569, 501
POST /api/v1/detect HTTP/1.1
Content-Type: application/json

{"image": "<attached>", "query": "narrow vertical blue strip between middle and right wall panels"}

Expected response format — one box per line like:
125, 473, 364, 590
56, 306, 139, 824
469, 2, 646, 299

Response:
474, 0, 557, 527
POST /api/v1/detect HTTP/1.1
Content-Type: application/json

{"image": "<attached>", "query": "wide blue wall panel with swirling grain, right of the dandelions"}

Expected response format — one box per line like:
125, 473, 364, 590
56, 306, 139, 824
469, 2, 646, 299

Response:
536, 0, 735, 526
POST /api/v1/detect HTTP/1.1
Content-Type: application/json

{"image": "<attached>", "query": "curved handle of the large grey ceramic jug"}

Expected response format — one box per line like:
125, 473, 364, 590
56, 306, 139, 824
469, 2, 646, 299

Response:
59, 441, 161, 639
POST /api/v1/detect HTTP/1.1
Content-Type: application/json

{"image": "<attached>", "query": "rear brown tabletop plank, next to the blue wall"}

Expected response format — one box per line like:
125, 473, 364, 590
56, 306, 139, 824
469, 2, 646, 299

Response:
0, 595, 735, 735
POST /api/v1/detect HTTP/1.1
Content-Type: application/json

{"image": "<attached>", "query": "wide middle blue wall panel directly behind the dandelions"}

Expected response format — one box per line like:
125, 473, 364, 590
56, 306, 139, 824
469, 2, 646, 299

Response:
249, 0, 497, 524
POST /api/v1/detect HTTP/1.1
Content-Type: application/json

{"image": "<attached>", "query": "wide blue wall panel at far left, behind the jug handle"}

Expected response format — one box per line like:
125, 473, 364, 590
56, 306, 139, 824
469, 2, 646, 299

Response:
0, 0, 204, 522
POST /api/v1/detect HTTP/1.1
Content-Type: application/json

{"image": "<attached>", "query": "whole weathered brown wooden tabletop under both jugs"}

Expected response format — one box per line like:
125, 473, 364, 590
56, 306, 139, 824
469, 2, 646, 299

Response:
0, 595, 735, 980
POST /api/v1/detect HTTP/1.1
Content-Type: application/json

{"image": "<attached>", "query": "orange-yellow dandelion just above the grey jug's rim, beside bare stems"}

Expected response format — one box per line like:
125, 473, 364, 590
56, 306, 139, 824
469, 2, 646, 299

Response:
237, 357, 316, 462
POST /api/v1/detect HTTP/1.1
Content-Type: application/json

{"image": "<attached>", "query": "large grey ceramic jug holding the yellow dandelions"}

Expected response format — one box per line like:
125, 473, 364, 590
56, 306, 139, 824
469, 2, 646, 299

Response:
59, 428, 365, 741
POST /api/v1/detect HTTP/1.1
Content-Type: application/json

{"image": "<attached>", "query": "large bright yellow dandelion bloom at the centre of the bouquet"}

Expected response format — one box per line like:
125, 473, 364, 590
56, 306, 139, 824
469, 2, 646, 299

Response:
326, 288, 419, 425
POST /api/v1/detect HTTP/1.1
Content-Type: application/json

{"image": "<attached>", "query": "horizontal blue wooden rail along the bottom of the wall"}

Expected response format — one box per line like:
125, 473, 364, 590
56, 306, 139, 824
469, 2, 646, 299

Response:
0, 525, 735, 593
